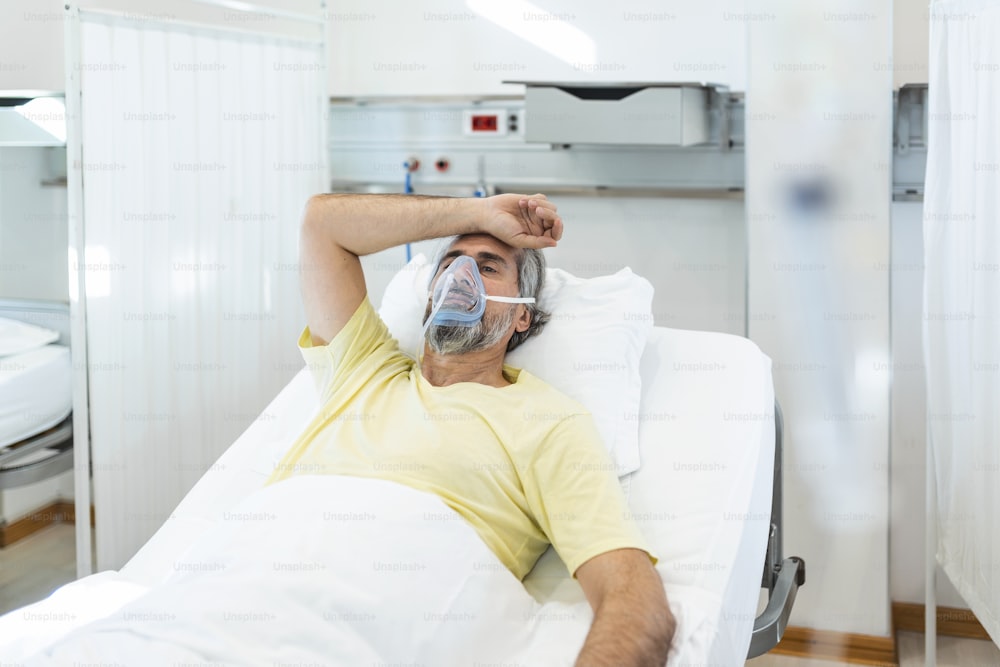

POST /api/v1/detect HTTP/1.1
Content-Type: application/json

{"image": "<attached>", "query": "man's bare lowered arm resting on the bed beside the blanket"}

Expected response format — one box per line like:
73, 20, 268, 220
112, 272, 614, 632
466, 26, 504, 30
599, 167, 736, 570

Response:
576, 549, 676, 667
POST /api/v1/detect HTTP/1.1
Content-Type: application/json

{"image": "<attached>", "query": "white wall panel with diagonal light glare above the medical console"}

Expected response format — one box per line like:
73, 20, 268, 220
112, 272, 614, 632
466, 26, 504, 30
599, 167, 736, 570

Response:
328, 0, 747, 96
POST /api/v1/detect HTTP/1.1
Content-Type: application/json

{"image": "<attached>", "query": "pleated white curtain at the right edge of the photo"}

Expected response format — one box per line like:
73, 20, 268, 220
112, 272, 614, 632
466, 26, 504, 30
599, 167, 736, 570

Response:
924, 0, 1000, 644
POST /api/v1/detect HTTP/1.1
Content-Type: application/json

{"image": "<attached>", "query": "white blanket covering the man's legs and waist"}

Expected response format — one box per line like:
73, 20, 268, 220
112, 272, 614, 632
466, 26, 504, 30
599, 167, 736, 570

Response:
15, 476, 591, 667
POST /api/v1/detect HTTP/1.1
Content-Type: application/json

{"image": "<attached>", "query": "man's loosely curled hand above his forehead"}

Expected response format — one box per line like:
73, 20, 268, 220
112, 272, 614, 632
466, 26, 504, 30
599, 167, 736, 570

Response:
483, 194, 563, 249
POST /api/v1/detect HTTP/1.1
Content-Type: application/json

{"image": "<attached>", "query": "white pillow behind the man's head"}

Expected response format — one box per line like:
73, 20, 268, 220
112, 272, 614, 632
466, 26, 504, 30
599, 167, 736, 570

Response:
379, 254, 653, 476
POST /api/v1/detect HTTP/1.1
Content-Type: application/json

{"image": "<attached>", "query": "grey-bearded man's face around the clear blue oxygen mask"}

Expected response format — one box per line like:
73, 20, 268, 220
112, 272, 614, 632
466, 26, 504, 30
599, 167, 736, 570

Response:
423, 234, 530, 354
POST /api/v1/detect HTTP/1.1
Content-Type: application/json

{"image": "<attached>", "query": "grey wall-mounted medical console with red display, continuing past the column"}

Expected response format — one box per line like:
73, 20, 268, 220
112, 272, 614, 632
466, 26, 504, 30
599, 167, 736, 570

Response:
329, 82, 927, 199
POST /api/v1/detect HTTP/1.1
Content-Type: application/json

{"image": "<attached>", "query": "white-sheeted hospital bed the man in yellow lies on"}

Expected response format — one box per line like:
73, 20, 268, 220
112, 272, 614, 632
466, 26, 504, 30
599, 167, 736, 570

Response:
0, 268, 804, 665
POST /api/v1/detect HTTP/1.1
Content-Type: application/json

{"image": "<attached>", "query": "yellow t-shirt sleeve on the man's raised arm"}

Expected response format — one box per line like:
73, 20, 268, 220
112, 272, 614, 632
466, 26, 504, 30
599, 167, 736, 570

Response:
299, 296, 400, 405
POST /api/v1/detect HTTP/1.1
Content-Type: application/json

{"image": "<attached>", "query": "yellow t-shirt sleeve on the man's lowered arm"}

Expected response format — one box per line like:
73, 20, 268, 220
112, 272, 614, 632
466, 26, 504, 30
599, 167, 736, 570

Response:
525, 414, 656, 577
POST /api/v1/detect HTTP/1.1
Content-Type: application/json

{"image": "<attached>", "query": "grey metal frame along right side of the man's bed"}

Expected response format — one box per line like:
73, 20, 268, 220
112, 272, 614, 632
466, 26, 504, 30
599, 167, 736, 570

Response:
747, 398, 806, 658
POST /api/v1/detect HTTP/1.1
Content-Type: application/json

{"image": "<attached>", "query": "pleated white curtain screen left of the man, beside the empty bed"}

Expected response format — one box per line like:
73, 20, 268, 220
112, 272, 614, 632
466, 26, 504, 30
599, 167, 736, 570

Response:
80, 11, 326, 569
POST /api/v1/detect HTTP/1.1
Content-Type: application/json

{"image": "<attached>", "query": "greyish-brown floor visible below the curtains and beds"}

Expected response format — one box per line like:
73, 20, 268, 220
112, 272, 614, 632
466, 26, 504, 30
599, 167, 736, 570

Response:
0, 524, 1000, 667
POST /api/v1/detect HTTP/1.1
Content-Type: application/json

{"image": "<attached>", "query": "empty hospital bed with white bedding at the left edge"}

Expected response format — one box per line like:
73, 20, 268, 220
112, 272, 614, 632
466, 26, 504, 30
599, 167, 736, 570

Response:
0, 299, 73, 489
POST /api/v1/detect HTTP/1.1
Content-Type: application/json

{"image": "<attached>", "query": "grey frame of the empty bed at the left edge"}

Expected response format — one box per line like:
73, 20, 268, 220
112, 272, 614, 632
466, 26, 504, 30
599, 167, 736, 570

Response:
0, 299, 73, 489
